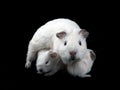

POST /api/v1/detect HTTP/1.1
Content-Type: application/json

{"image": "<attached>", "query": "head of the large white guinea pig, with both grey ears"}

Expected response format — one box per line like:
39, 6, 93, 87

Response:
56, 29, 89, 64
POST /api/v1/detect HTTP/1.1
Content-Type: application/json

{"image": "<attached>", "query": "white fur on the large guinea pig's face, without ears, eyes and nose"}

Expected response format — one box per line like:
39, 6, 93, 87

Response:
57, 31, 87, 64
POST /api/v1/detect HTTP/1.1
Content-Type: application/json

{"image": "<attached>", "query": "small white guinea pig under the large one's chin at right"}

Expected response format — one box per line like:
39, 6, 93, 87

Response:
67, 49, 96, 77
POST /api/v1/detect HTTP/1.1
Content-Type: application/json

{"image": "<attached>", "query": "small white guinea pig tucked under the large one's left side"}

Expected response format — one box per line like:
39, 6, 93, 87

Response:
36, 50, 64, 76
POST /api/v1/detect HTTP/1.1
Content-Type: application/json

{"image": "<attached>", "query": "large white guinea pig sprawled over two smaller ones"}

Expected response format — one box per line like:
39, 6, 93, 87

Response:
25, 18, 89, 68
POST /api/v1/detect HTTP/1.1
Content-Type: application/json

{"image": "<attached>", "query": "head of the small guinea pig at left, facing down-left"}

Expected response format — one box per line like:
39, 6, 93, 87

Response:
36, 51, 57, 74
